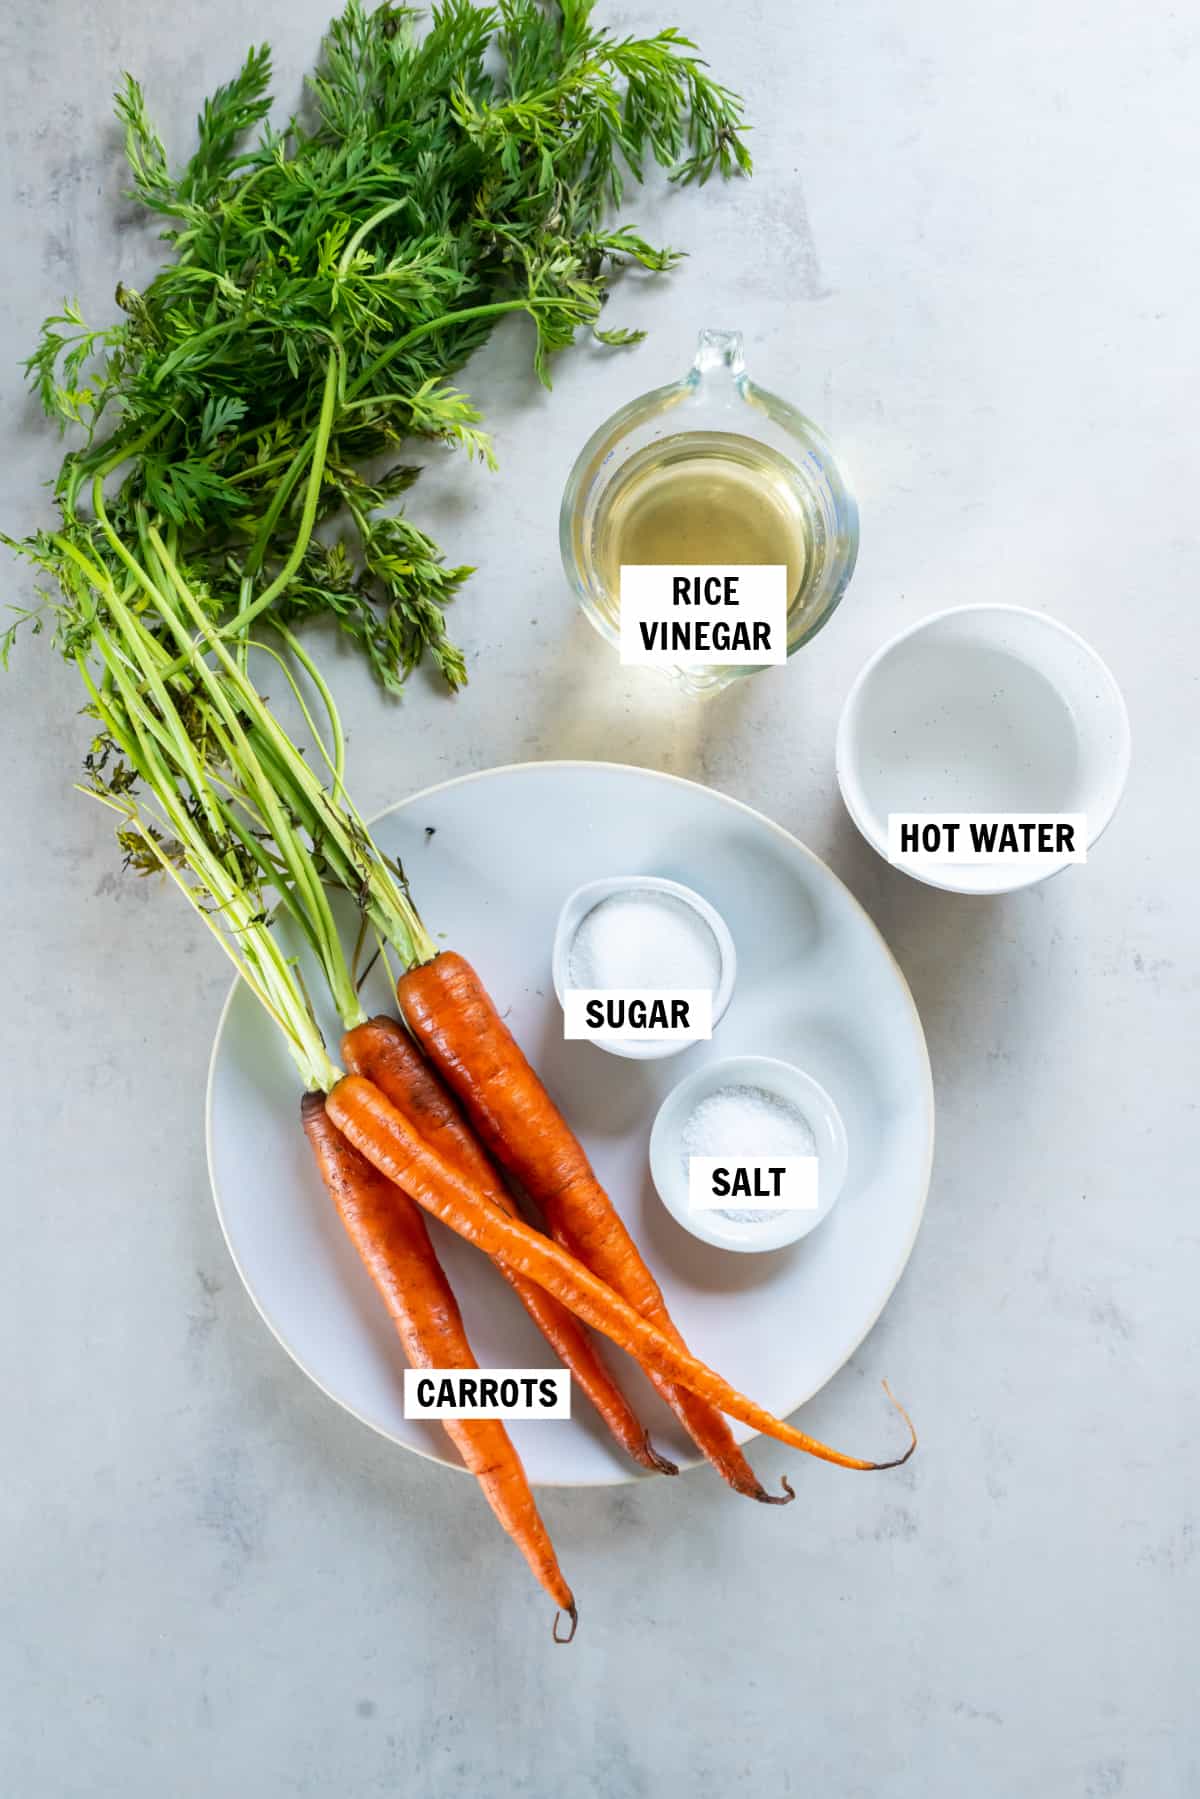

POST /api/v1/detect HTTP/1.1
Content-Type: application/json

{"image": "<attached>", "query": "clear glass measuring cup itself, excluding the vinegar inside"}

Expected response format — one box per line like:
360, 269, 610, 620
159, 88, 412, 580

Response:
560, 331, 858, 693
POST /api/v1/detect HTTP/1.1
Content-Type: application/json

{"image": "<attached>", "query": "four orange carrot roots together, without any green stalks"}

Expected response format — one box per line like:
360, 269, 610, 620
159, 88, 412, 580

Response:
325, 978, 916, 1641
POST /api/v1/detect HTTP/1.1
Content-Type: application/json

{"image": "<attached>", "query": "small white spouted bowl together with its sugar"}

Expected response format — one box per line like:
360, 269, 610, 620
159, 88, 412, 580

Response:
552, 874, 738, 1061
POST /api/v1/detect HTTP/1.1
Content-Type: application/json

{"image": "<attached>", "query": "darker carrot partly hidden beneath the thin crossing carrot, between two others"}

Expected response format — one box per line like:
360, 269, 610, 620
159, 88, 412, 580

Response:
342, 1018, 678, 1473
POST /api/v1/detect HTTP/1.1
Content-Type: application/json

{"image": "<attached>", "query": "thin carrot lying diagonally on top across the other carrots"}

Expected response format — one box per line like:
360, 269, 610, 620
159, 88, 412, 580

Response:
326, 1074, 918, 1470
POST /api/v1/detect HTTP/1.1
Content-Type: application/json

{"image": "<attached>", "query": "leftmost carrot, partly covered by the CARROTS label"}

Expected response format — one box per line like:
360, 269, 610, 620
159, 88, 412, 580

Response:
300, 1094, 578, 1642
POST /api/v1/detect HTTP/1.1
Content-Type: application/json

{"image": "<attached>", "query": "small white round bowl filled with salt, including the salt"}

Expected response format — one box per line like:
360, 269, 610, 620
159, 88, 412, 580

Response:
649, 1056, 847, 1254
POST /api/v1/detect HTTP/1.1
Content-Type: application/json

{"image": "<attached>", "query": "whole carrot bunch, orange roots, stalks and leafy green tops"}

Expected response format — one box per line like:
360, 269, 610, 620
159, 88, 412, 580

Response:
0, 0, 916, 1641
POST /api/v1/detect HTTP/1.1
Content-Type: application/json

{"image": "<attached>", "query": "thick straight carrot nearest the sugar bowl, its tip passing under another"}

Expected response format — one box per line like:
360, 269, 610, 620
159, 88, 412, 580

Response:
396, 950, 795, 1506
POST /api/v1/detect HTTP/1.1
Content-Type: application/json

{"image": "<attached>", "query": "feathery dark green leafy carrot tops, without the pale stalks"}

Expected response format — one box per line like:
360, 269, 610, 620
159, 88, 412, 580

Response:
11, 0, 750, 694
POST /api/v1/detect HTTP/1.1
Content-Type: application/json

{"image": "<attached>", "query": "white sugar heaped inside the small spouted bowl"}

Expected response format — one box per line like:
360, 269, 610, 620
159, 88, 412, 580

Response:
570, 887, 721, 991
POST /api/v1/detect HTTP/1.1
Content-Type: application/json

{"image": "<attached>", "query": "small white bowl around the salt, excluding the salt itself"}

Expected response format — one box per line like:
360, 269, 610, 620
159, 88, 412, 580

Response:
649, 1056, 847, 1254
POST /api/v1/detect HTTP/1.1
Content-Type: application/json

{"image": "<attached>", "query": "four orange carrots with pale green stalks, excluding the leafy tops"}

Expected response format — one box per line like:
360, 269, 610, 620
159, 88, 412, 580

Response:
9, 500, 916, 1641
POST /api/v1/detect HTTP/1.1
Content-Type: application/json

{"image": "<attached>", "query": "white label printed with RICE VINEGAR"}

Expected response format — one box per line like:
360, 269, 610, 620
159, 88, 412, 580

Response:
621, 563, 788, 669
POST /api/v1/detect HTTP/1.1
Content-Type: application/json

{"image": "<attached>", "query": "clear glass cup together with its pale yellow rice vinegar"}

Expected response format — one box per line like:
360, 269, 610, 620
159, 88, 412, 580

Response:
560, 331, 858, 693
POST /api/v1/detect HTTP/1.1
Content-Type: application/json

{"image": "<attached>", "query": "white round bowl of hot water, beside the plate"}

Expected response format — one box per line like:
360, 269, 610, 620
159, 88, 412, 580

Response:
837, 606, 1130, 894
